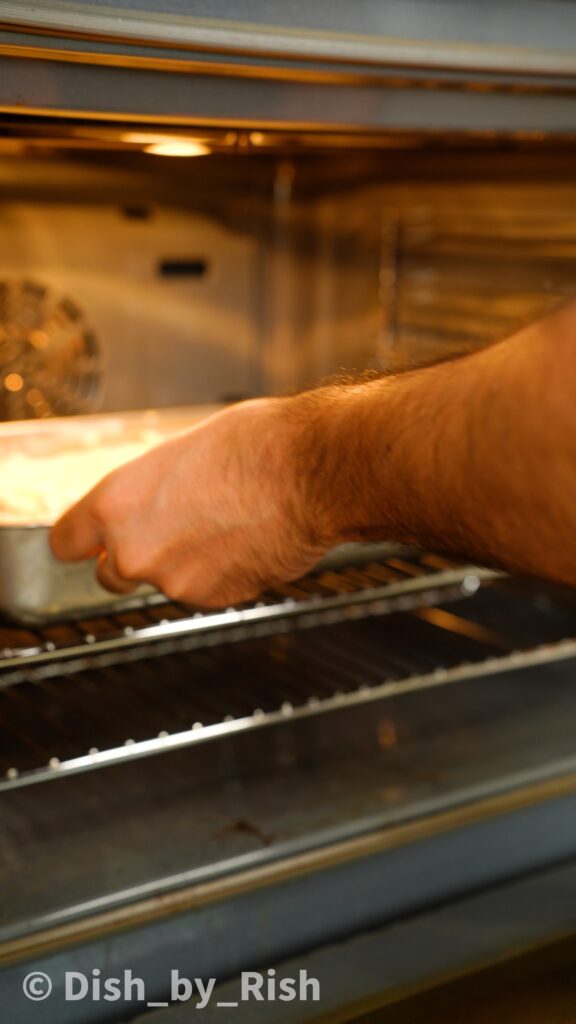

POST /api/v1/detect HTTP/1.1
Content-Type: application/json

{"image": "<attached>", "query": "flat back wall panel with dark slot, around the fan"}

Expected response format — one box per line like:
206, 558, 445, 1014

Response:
0, 160, 258, 418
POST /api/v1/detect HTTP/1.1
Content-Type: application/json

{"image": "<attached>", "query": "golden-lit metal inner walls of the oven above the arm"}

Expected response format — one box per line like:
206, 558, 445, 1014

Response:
0, 146, 576, 409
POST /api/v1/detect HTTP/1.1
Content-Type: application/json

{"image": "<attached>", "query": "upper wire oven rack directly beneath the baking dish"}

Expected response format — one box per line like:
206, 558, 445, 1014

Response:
0, 552, 498, 675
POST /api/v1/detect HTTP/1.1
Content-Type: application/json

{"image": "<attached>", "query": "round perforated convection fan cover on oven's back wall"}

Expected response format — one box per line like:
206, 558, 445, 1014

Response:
0, 279, 100, 420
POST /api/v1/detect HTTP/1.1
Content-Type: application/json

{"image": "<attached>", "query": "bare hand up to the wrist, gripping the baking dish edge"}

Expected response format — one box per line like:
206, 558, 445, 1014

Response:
51, 398, 332, 607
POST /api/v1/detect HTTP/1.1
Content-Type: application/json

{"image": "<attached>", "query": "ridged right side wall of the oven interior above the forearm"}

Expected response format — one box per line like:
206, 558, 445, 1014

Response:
366, 178, 576, 367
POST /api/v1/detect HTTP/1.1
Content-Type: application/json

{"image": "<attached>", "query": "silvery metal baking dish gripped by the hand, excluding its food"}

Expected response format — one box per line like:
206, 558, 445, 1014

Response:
0, 406, 220, 624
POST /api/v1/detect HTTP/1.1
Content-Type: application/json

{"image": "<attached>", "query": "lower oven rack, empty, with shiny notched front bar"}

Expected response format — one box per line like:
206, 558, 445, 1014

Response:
0, 581, 576, 788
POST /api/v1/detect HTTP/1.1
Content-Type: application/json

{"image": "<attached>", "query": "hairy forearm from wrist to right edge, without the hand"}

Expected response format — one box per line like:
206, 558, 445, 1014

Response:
291, 307, 576, 583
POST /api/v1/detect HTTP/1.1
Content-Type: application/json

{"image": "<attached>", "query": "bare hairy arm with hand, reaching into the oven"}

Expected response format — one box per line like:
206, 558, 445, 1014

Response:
52, 306, 576, 606
